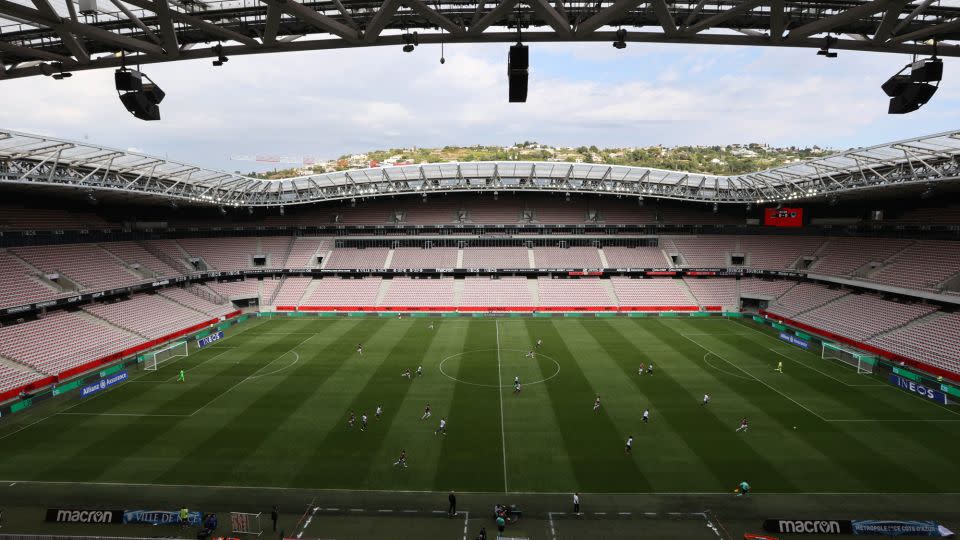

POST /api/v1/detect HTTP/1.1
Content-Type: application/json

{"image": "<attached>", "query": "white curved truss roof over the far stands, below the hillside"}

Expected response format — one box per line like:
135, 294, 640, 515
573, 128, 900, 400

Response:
0, 126, 960, 206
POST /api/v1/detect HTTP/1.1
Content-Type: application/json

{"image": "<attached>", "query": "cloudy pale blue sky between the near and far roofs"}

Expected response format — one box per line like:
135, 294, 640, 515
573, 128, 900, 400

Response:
0, 43, 960, 172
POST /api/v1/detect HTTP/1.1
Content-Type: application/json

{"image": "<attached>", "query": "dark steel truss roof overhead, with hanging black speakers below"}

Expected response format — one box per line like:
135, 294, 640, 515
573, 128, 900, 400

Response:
0, 0, 960, 78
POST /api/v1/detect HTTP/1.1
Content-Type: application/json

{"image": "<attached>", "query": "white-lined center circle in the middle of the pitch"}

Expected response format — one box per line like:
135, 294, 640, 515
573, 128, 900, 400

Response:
440, 349, 560, 388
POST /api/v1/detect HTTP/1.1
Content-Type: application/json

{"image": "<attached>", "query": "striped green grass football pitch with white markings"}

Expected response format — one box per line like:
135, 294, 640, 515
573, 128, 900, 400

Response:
0, 318, 960, 493
